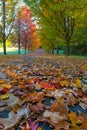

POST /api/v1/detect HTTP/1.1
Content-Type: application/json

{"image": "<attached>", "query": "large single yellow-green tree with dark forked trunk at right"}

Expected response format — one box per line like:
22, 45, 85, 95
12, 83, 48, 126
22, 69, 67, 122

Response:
25, 0, 87, 55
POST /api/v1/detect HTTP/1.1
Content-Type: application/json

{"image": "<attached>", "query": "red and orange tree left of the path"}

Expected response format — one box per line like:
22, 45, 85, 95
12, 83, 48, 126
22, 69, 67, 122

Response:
15, 6, 38, 54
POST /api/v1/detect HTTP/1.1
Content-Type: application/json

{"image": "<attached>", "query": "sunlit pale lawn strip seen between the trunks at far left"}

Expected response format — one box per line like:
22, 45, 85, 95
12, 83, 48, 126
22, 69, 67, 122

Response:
0, 47, 28, 54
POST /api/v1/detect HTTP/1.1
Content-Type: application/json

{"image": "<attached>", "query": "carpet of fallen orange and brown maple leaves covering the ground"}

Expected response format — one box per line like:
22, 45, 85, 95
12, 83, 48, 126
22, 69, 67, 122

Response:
0, 55, 87, 130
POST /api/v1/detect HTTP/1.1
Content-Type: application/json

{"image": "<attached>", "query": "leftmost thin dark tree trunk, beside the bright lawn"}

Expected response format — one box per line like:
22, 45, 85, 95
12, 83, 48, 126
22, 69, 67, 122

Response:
3, 1, 6, 55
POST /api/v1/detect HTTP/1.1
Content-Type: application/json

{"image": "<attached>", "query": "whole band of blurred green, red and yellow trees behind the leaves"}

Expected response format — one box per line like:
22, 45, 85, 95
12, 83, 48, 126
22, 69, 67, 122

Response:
0, 0, 87, 55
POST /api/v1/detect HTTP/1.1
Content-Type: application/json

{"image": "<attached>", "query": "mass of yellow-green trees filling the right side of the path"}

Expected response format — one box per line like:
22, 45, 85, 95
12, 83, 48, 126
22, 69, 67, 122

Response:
24, 0, 87, 55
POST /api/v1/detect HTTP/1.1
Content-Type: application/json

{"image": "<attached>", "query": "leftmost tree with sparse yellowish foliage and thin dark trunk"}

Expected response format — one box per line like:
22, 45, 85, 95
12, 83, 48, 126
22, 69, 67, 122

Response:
0, 0, 18, 55
